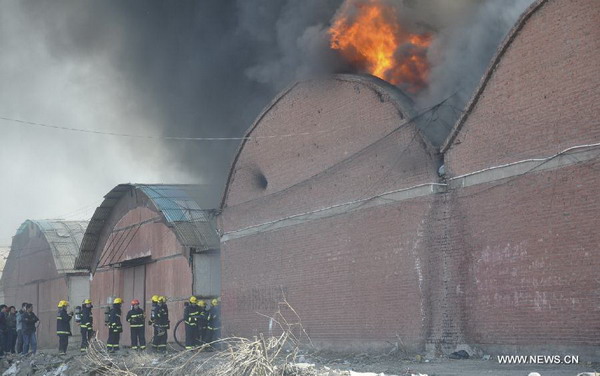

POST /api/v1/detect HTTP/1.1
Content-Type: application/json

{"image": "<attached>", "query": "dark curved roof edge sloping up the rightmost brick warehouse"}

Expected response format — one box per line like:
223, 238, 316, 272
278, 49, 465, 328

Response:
440, 0, 548, 153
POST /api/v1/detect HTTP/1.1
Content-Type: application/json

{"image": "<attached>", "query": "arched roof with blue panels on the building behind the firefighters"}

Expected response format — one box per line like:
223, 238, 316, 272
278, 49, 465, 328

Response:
75, 184, 220, 270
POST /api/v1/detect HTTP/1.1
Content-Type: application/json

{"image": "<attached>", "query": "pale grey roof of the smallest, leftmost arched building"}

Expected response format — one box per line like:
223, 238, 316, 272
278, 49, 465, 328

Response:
17, 219, 88, 274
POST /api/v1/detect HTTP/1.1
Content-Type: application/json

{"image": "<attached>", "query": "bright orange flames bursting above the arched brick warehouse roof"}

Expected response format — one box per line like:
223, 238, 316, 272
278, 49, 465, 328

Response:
329, 0, 432, 93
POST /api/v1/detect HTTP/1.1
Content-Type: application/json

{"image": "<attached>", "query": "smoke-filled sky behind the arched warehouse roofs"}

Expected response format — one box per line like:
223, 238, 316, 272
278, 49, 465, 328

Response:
0, 0, 532, 244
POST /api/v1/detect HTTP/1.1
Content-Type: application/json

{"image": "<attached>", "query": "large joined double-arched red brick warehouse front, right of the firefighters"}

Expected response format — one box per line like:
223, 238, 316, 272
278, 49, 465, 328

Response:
218, 0, 600, 359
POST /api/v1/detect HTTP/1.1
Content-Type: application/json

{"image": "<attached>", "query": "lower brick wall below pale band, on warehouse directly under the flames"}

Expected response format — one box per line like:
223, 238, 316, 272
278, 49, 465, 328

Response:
222, 198, 431, 348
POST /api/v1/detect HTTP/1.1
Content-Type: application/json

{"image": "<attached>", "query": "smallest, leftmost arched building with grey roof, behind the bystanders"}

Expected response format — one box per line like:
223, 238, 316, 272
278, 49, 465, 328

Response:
1, 219, 90, 347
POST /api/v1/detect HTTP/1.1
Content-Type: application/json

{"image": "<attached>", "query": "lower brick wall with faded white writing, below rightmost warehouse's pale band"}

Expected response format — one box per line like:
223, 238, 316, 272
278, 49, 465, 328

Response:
454, 160, 600, 346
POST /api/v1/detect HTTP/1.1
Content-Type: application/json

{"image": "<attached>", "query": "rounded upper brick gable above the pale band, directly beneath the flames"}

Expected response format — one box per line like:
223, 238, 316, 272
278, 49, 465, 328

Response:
222, 76, 436, 231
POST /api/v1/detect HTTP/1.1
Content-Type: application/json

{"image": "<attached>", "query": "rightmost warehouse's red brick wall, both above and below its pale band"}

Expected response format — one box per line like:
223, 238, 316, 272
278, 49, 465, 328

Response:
445, 0, 600, 349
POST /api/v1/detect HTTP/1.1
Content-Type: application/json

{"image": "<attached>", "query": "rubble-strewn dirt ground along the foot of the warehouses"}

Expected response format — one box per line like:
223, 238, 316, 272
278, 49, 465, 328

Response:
0, 349, 600, 376
